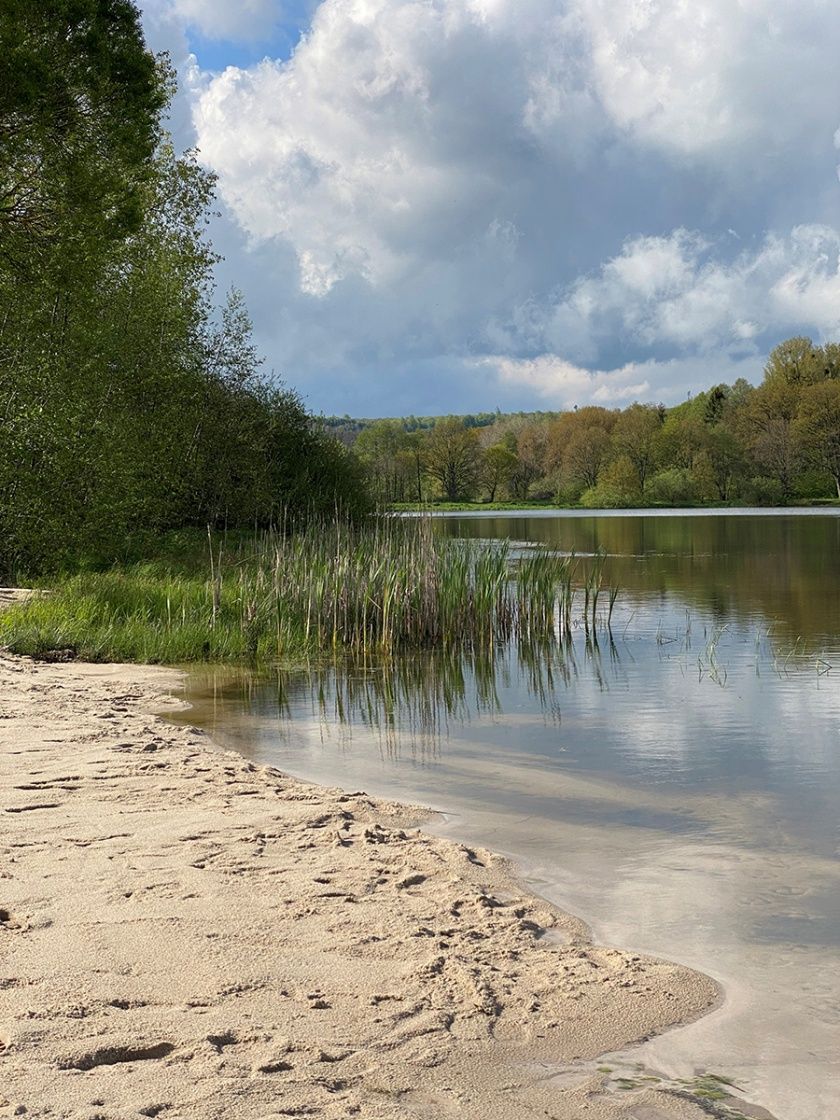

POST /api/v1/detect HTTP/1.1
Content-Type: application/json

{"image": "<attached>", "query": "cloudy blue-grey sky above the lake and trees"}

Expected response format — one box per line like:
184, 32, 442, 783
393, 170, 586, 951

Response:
141, 0, 840, 417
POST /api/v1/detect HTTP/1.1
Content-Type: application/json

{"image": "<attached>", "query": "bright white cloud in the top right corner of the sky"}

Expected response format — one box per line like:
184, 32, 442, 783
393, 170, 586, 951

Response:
572, 0, 840, 160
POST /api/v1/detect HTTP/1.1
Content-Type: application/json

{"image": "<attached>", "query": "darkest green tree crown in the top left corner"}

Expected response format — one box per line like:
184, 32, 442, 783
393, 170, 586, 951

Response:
0, 0, 171, 273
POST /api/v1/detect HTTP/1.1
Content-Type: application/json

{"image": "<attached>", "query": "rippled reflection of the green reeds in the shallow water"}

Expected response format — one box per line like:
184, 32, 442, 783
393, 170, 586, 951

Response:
220, 624, 636, 759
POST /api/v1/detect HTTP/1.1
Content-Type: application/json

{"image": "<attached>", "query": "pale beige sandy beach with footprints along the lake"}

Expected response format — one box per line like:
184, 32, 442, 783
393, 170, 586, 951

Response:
0, 654, 734, 1120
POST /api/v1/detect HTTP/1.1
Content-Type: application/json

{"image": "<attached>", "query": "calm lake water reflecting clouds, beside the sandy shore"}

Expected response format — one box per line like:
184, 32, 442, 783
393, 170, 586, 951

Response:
179, 511, 840, 1120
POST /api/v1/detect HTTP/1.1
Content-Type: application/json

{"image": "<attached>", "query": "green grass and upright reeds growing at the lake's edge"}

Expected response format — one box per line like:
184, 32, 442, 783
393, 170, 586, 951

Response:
0, 517, 614, 663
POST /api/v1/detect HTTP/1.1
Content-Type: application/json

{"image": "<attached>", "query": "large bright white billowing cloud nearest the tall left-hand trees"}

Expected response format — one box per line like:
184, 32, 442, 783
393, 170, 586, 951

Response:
195, 0, 568, 295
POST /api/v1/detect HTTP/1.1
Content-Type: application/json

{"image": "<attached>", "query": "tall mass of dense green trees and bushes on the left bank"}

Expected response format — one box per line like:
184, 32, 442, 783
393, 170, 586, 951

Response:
0, 0, 364, 576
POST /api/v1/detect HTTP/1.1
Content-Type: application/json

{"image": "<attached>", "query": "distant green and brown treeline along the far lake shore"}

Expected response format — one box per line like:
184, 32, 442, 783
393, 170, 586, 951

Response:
340, 338, 840, 507
